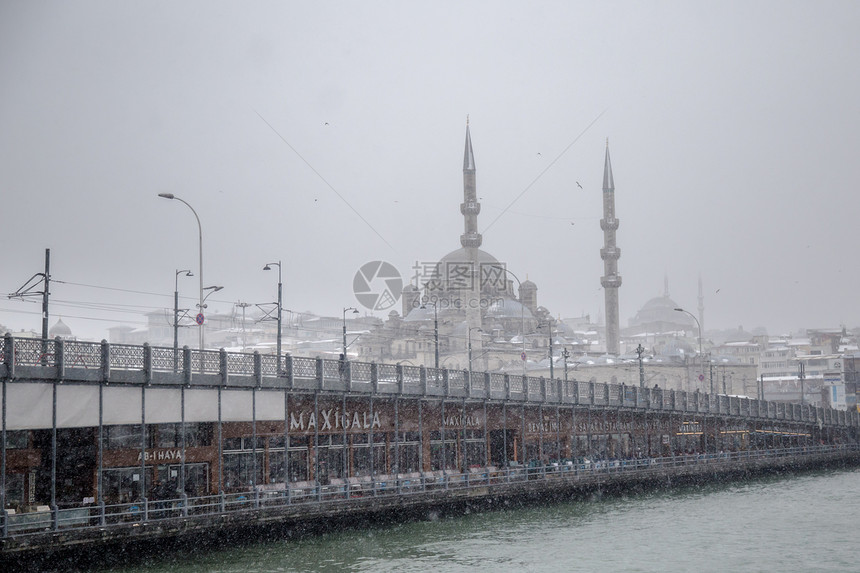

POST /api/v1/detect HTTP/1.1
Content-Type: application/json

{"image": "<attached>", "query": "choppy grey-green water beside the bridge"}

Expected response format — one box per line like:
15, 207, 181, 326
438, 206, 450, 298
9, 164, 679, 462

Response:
87, 470, 860, 573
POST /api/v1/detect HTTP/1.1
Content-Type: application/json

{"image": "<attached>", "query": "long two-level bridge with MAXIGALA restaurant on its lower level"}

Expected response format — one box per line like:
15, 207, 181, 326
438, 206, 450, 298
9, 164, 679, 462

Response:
0, 334, 860, 555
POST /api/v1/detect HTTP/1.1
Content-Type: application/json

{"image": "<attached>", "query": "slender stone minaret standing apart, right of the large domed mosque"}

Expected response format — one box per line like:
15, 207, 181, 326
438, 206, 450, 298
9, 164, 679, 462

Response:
600, 139, 621, 356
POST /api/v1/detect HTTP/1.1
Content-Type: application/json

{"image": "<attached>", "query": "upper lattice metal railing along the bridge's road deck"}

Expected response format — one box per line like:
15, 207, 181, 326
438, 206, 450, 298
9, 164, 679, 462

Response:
0, 334, 860, 427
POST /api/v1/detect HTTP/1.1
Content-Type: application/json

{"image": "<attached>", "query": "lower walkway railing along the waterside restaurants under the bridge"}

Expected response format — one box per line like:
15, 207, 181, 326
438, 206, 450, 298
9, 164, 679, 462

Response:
0, 445, 860, 545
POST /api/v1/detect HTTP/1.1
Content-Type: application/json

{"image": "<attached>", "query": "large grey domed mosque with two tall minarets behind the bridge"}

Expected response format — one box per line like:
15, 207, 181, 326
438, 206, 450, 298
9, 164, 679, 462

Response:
357, 121, 621, 372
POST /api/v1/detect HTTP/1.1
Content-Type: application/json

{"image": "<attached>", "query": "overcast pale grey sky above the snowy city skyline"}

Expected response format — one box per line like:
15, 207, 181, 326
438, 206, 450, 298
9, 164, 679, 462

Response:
0, 0, 860, 338
